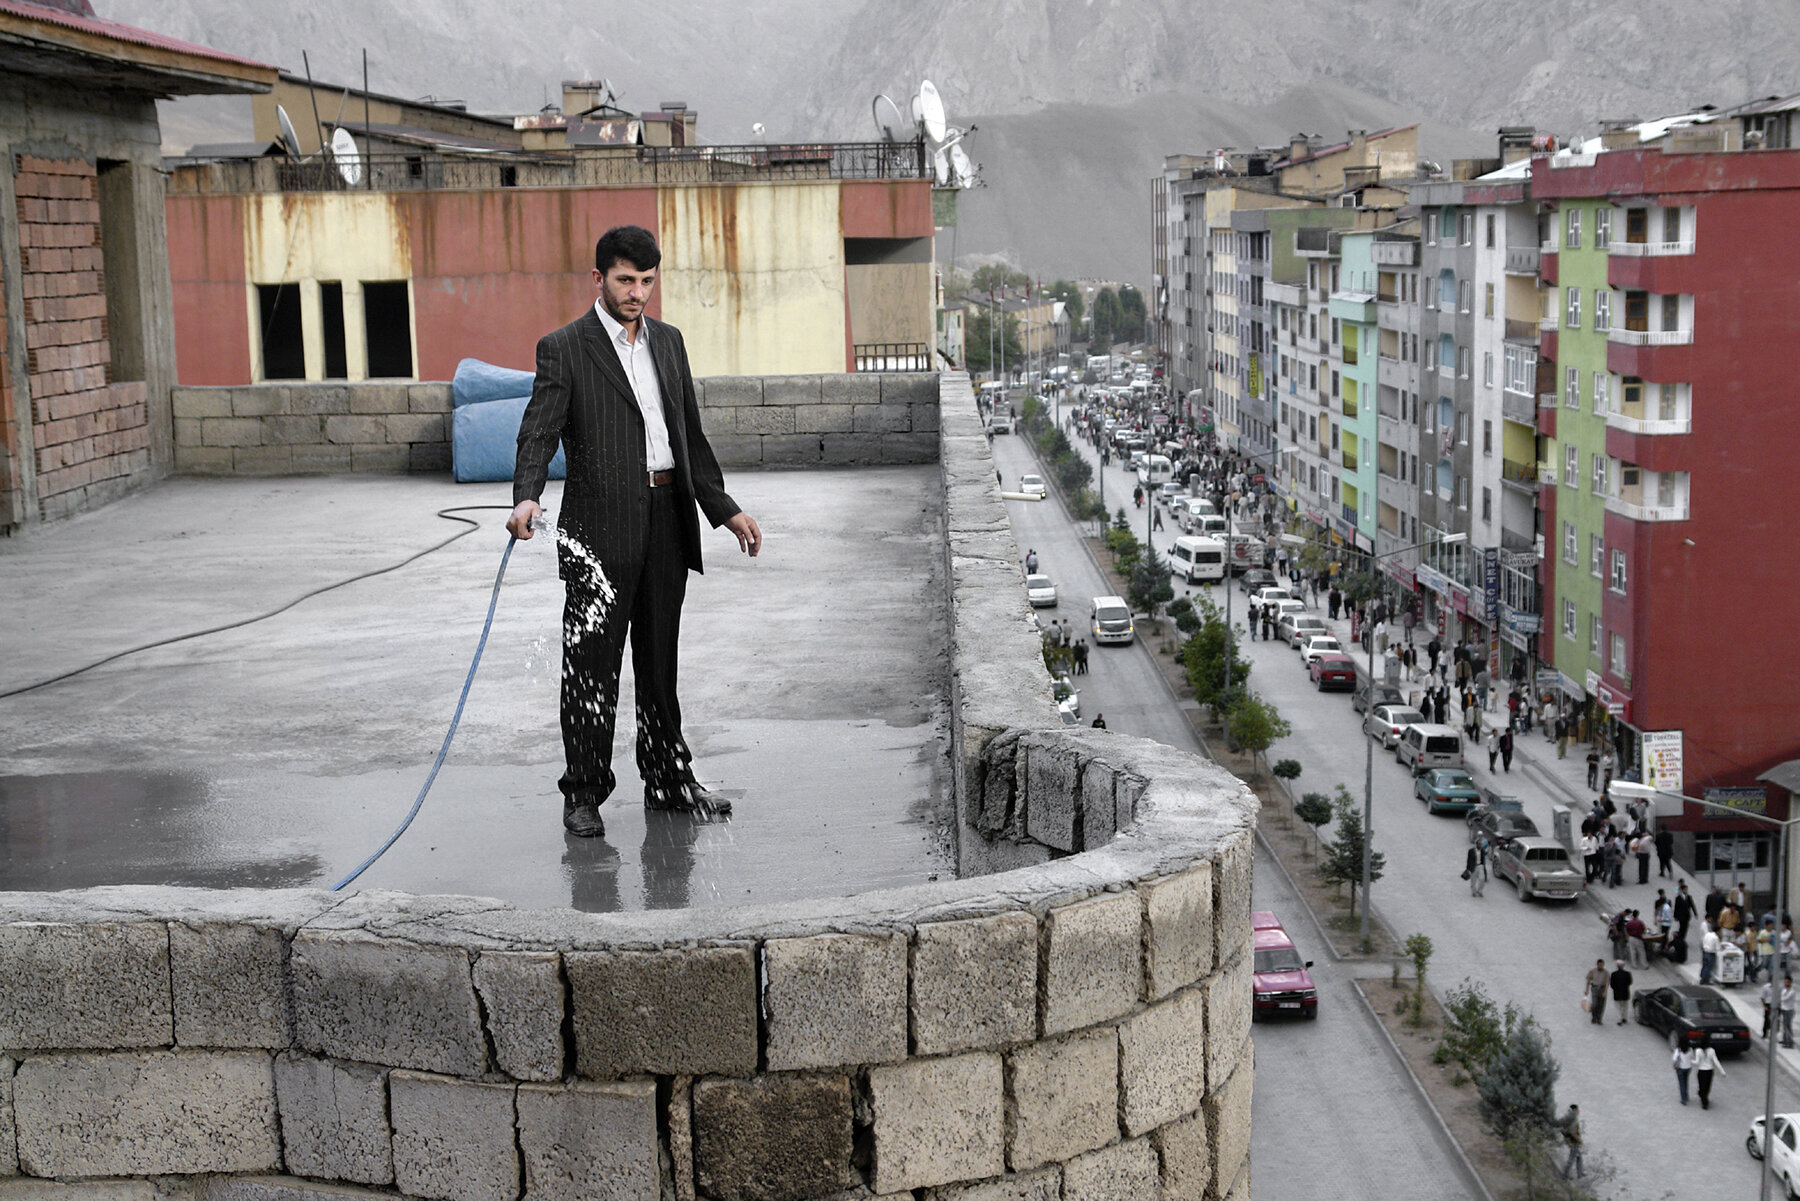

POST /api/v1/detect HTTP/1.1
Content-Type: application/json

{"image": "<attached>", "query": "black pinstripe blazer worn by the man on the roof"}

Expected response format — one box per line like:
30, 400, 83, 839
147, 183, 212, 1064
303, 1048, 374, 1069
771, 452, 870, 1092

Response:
513, 308, 738, 580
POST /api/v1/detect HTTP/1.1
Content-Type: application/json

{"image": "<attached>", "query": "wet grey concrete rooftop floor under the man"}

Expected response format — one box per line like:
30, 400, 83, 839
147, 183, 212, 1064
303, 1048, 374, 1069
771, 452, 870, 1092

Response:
0, 466, 949, 911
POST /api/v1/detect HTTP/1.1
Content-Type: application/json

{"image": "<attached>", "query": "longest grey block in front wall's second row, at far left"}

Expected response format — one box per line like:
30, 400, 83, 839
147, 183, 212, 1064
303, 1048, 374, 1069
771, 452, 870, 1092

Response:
13, 1052, 281, 1176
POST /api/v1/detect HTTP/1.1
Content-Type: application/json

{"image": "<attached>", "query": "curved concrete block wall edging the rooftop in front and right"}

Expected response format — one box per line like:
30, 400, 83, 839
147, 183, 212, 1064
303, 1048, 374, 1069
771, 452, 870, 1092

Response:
0, 370, 1255, 1201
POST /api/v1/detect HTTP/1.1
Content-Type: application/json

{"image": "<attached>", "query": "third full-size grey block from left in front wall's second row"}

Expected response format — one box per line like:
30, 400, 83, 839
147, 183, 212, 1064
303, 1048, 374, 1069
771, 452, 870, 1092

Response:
387, 1071, 518, 1201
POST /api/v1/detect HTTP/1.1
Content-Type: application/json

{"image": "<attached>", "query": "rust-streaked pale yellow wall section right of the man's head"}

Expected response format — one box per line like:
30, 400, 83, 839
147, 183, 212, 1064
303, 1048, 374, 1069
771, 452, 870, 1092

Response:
657, 180, 846, 376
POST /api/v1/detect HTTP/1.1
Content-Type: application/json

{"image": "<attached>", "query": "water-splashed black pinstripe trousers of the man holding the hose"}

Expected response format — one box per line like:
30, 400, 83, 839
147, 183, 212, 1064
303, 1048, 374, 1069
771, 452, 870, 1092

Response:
558, 488, 693, 807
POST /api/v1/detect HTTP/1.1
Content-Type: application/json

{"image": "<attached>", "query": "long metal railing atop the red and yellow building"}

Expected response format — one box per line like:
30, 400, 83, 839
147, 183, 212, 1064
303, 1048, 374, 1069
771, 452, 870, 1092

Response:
167, 140, 931, 194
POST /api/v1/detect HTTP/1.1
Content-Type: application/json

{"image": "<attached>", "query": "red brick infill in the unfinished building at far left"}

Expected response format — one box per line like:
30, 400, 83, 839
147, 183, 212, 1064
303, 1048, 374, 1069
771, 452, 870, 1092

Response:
14, 155, 149, 519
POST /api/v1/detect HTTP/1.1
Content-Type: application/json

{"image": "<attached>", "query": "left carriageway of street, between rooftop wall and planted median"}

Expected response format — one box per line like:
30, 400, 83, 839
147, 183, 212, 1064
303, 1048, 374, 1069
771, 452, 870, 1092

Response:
994, 434, 1474, 1201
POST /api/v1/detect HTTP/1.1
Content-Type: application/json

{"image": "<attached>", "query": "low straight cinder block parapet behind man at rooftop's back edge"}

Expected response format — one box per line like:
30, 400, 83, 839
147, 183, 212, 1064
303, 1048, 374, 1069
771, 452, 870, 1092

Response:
171, 373, 938, 475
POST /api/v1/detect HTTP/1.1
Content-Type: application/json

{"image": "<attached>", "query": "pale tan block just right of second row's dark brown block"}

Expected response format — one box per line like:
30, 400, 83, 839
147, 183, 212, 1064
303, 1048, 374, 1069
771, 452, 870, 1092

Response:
869, 1052, 1006, 1192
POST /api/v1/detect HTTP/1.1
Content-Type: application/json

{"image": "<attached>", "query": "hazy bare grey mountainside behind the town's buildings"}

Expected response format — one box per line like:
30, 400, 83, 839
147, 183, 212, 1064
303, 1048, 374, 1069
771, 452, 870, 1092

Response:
99, 0, 1800, 281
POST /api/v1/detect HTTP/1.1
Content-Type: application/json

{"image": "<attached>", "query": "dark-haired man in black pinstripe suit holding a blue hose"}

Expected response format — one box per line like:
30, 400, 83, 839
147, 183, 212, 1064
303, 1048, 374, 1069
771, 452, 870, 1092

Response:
506, 225, 763, 837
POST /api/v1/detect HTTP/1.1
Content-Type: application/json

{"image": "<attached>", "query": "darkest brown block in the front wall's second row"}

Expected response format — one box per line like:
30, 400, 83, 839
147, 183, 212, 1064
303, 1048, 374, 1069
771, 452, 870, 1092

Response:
693, 1075, 860, 1201
